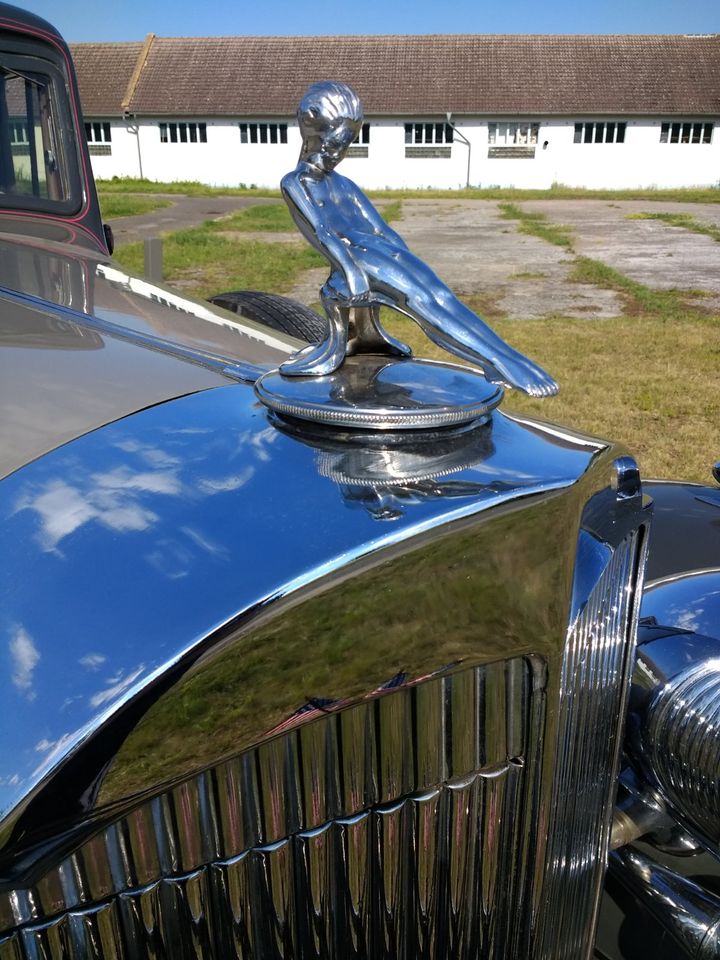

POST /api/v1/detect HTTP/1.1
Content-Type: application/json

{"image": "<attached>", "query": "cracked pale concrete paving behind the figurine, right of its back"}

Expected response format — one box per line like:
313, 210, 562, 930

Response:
290, 199, 720, 320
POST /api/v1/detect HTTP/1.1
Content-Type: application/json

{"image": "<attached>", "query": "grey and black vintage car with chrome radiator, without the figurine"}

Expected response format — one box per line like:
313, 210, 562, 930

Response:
0, 4, 720, 960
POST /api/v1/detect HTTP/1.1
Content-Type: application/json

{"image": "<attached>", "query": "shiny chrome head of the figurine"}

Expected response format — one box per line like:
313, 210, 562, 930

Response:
297, 80, 363, 171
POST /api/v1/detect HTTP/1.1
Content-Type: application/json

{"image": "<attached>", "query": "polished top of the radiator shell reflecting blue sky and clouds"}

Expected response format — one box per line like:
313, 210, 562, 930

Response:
0, 384, 599, 844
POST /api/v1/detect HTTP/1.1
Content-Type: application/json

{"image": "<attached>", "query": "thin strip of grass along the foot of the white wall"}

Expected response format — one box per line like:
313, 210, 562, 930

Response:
98, 177, 720, 203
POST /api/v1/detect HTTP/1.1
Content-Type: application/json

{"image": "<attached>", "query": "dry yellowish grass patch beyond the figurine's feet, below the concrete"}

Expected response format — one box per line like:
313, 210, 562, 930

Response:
384, 296, 720, 483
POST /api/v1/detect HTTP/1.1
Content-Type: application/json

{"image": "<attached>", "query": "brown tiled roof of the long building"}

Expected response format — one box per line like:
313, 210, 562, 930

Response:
73, 35, 720, 117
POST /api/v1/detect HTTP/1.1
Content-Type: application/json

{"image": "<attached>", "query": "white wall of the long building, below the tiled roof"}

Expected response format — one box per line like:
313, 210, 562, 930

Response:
92, 117, 720, 189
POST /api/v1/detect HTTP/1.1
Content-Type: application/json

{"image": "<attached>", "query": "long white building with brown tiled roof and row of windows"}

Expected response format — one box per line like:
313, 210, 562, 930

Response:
73, 34, 720, 189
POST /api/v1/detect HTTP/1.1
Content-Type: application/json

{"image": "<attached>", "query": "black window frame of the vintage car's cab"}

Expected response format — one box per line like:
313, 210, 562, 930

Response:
0, 34, 86, 217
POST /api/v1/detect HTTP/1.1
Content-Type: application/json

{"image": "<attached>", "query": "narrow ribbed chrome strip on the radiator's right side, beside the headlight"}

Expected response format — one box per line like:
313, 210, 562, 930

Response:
539, 533, 641, 960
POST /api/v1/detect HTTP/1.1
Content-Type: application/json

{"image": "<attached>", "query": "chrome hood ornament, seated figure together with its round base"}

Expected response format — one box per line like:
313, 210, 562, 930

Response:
256, 81, 558, 429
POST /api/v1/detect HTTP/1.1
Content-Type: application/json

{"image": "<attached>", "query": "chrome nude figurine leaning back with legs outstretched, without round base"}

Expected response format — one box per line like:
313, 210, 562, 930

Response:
280, 81, 558, 397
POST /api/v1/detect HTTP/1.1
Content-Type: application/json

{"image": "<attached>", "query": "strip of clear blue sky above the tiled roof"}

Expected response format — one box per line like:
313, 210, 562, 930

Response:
20, 0, 720, 41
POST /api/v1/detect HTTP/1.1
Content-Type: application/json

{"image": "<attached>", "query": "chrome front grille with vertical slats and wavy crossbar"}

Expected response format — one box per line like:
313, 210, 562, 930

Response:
0, 658, 545, 960
